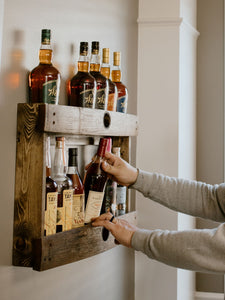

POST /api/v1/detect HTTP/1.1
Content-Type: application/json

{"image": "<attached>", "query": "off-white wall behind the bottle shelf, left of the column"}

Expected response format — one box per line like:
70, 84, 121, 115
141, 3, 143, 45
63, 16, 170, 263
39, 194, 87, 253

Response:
0, 0, 138, 300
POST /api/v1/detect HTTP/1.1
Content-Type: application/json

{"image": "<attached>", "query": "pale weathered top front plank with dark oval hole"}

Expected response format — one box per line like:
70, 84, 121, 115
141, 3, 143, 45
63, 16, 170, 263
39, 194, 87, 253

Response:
36, 104, 138, 136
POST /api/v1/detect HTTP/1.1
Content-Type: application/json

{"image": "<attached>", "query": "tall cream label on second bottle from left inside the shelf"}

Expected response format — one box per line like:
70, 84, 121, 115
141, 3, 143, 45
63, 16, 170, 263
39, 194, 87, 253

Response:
63, 189, 73, 230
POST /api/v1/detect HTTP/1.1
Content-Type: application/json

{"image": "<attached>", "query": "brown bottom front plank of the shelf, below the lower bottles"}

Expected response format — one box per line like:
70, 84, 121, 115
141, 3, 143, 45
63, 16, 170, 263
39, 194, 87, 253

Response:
33, 212, 136, 271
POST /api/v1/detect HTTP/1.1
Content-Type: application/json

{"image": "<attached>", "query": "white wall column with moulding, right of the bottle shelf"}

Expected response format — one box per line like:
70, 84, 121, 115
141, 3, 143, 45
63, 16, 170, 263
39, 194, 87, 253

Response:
135, 0, 197, 300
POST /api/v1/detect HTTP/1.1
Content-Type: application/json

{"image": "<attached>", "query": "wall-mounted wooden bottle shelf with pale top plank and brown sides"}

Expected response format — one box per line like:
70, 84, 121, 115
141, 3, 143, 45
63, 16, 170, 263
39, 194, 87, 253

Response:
13, 104, 138, 271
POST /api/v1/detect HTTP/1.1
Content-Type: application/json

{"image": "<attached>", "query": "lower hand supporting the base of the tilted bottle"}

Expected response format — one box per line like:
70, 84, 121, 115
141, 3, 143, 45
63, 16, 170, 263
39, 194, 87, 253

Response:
92, 212, 138, 248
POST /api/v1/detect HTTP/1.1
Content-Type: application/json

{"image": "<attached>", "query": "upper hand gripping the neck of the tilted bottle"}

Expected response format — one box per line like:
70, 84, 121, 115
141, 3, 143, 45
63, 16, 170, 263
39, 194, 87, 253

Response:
102, 152, 138, 186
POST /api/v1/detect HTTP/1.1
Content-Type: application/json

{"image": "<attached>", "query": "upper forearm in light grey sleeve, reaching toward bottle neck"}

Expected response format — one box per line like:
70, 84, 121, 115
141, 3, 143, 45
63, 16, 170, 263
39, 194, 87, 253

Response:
131, 170, 225, 222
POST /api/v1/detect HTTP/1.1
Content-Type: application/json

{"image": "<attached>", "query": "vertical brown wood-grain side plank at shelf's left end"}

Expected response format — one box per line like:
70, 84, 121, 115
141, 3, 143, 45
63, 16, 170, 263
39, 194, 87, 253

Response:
13, 104, 45, 266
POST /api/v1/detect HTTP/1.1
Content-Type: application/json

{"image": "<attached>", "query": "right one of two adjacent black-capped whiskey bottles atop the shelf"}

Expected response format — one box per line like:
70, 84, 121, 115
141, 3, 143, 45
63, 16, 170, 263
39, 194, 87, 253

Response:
90, 42, 109, 110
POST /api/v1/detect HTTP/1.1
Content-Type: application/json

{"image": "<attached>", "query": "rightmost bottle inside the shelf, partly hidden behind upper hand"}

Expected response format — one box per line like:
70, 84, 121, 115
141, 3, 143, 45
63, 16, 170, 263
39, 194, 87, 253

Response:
112, 147, 127, 216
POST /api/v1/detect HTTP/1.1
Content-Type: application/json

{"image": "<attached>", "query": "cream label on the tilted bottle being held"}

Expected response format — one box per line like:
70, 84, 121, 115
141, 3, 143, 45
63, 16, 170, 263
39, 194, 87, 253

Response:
84, 191, 104, 223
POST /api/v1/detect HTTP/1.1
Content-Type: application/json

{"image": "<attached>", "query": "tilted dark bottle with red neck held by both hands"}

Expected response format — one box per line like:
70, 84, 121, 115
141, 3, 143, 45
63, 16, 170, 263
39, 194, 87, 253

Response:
84, 138, 108, 223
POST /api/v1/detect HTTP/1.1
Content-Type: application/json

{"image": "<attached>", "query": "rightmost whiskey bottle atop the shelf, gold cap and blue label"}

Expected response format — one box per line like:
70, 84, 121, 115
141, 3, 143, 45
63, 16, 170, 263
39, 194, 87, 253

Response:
112, 52, 128, 113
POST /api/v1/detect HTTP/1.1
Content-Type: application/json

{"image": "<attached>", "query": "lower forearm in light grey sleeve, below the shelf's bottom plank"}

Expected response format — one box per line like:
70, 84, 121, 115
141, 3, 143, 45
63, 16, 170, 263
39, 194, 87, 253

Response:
131, 224, 225, 273
